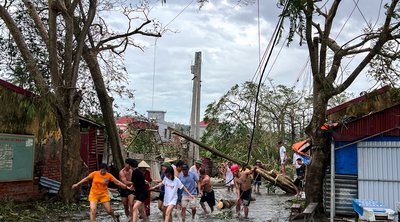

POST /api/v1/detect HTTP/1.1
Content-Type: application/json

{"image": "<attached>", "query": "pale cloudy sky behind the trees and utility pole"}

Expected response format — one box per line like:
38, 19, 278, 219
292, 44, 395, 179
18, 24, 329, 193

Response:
114, 0, 388, 124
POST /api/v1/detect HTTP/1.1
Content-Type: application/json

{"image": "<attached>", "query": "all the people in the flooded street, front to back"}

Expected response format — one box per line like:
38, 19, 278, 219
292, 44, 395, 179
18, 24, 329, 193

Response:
72, 142, 305, 222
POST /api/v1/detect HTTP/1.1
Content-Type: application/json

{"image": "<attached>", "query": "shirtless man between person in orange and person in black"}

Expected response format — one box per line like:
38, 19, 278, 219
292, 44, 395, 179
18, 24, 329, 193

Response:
119, 158, 134, 217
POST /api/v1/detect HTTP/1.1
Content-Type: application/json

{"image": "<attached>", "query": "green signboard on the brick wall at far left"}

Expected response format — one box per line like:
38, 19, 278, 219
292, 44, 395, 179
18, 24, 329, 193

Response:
0, 133, 34, 182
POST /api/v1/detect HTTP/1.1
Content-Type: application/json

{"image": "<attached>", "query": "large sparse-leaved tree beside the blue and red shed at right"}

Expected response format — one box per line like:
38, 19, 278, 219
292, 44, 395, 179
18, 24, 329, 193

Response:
279, 0, 400, 205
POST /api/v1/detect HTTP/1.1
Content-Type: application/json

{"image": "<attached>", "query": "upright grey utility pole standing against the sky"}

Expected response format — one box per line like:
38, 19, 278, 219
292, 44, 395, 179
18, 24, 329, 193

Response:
188, 52, 201, 162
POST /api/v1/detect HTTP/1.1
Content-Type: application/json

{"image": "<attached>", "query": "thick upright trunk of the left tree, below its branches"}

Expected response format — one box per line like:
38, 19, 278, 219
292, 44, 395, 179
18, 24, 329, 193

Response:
56, 95, 84, 203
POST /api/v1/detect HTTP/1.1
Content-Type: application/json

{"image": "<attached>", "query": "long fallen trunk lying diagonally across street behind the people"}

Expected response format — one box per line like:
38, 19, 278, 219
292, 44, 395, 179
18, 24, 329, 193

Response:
168, 128, 297, 194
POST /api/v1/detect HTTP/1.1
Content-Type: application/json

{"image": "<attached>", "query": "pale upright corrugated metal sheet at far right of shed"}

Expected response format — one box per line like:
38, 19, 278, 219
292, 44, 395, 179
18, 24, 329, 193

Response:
357, 141, 400, 210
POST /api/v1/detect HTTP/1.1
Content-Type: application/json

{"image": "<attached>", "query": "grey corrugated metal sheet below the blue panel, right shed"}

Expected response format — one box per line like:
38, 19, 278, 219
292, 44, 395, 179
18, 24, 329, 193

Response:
323, 173, 358, 215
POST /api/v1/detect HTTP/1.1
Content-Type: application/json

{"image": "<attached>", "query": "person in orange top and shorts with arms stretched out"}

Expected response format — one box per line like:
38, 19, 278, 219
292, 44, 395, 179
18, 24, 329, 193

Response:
72, 164, 132, 222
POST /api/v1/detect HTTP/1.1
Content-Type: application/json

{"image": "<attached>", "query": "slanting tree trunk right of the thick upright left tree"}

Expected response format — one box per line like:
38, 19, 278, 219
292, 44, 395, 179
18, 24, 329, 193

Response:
83, 47, 124, 169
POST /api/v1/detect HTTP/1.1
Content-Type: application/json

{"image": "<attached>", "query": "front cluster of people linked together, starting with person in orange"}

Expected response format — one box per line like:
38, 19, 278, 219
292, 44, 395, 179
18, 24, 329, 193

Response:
72, 159, 215, 222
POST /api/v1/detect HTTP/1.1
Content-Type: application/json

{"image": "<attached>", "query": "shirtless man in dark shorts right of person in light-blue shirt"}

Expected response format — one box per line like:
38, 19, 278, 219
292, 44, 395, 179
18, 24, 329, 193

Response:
198, 168, 215, 214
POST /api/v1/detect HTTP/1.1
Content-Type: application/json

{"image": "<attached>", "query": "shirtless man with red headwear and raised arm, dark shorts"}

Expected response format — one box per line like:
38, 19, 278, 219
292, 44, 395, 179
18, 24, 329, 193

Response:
231, 164, 254, 219
